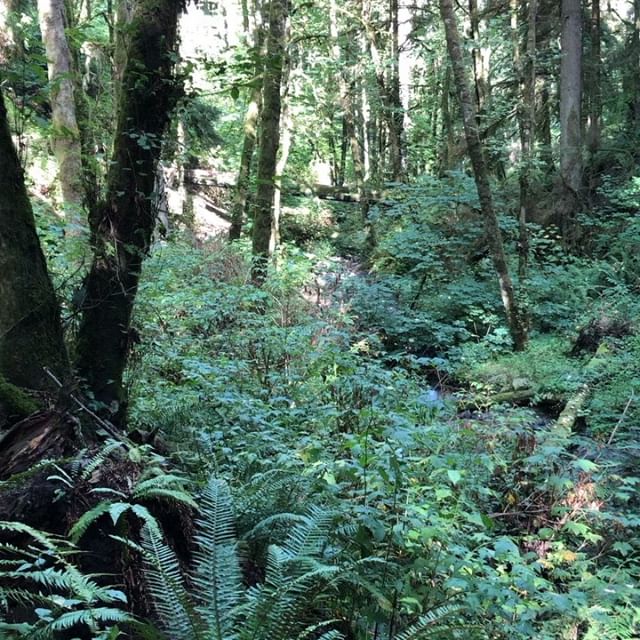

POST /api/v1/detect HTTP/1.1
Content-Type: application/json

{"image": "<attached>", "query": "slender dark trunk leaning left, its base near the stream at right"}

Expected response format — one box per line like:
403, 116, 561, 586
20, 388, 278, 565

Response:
440, 0, 527, 351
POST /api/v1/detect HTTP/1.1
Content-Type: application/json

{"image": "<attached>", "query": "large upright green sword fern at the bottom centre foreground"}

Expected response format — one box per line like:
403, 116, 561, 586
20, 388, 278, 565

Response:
138, 479, 462, 640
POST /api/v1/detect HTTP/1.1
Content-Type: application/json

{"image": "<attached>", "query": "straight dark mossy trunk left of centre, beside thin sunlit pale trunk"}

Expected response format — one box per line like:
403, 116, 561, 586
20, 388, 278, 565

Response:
252, 0, 288, 285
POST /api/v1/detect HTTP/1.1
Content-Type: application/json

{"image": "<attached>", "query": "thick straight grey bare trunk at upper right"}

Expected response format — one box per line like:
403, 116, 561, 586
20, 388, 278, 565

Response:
560, 0, 582, 235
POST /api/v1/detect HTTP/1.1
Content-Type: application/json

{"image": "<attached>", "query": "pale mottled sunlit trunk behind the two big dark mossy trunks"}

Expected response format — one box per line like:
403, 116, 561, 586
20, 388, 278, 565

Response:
38, 0, 83, 222
